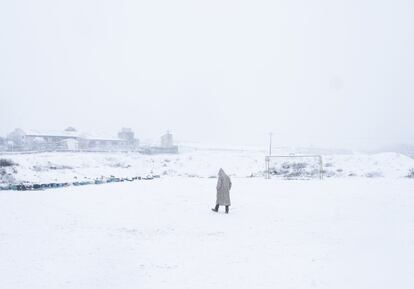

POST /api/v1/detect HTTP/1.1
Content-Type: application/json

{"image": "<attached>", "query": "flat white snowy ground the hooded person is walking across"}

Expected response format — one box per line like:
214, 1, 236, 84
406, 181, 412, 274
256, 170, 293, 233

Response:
0, 177, 414, 289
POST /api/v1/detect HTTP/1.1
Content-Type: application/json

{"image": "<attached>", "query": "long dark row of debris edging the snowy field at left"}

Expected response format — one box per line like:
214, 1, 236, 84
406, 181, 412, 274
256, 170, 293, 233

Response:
0, 175, 160, 191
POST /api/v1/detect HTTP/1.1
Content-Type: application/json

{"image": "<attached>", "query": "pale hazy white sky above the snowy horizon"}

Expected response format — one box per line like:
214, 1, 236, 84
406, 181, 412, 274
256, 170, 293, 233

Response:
0, 0, 414, 146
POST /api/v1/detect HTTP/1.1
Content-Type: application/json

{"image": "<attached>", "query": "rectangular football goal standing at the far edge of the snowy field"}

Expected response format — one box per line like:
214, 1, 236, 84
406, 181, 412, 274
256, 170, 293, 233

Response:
265, 155, 323, 180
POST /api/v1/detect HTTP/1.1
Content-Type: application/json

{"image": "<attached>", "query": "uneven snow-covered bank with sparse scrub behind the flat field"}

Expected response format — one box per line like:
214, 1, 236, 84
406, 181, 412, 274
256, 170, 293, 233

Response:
0, 148, 414, 184
